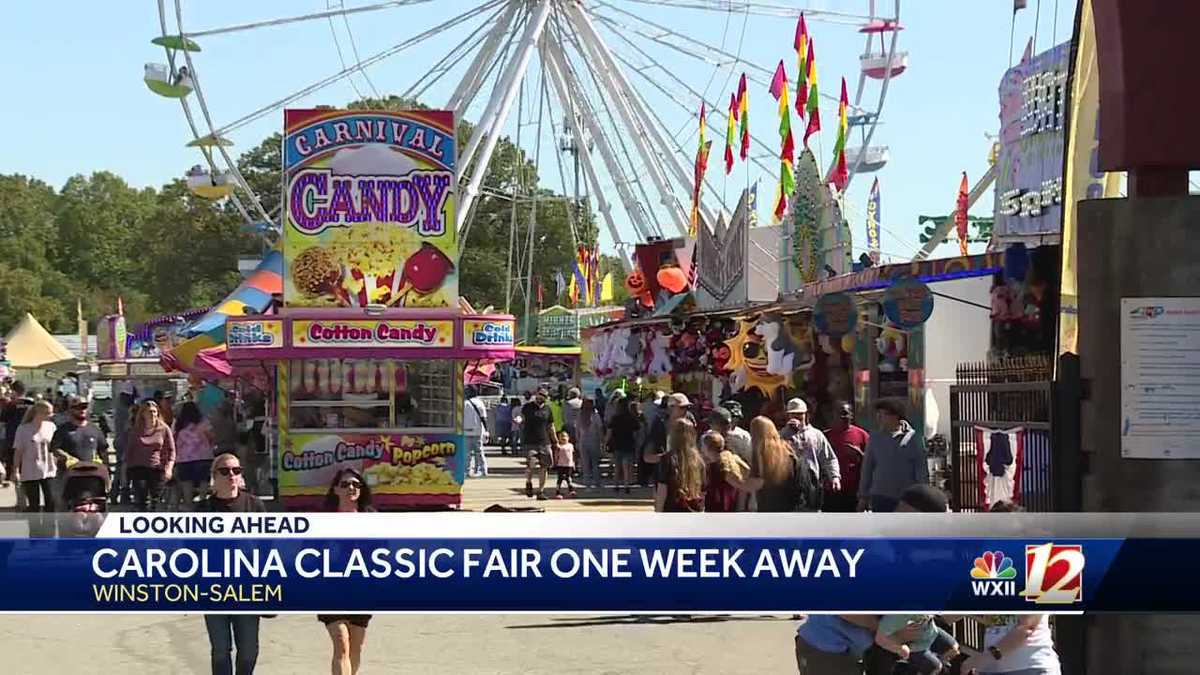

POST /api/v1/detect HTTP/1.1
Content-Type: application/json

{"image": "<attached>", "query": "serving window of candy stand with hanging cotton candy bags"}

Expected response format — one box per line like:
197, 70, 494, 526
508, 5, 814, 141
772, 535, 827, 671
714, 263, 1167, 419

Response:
289, 359, 455, 430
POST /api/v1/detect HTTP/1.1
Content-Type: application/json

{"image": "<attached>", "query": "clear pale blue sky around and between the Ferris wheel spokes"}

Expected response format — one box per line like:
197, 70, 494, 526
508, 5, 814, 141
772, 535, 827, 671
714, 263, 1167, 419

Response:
0, 0, 1074, 259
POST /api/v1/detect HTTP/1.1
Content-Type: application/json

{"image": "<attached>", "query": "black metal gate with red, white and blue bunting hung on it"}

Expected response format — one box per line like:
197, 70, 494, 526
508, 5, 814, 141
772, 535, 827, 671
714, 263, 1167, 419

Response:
950, 357, 1055, 512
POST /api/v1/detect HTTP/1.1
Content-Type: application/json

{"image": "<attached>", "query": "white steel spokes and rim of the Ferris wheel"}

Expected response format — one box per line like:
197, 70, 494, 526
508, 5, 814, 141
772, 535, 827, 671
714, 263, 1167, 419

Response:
157, 0, 900, 253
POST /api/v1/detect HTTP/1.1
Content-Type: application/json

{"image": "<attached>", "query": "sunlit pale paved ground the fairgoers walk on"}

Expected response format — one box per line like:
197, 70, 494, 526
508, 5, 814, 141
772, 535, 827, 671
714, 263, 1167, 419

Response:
0, 449, 796, 675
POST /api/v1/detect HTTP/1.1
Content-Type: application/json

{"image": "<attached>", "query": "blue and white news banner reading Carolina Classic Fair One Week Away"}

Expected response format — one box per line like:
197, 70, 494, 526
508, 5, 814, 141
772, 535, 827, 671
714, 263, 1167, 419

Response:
0, 513, 1200, 614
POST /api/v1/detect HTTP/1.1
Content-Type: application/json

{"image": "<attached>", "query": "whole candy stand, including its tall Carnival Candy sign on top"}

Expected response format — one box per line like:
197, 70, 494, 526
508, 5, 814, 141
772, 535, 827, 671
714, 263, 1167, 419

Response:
226, 109, 515, 509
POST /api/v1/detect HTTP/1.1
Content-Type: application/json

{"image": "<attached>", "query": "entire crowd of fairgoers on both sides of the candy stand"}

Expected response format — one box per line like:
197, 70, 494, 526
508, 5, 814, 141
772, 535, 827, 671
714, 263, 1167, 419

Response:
0, 374, 1061, 675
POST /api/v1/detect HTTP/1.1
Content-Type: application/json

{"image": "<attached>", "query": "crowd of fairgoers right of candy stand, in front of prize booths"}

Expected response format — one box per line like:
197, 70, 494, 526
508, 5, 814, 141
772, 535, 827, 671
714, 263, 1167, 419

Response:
487, 387, 929, 512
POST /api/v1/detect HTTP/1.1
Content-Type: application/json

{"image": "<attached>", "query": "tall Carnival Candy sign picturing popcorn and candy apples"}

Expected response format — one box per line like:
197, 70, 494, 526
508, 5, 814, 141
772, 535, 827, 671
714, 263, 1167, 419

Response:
283, 109, 458, 307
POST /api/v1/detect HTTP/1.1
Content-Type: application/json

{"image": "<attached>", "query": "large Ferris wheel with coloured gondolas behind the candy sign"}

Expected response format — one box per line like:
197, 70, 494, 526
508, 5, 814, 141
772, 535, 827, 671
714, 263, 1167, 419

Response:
144, 0, 907, 260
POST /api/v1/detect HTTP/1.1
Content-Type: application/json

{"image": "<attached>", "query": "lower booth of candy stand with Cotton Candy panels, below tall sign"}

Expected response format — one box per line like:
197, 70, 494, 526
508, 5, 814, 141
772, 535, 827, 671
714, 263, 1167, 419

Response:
227, 309, 514, 509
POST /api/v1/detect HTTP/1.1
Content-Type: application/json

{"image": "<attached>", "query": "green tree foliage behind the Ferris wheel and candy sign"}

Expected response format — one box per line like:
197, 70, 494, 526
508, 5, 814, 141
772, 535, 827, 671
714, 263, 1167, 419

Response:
0, 96, 625, 334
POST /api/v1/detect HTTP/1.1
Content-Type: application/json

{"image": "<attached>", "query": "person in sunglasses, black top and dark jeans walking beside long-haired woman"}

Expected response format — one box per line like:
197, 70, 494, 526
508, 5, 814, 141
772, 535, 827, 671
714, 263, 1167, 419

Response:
198, 453, 266, 675
